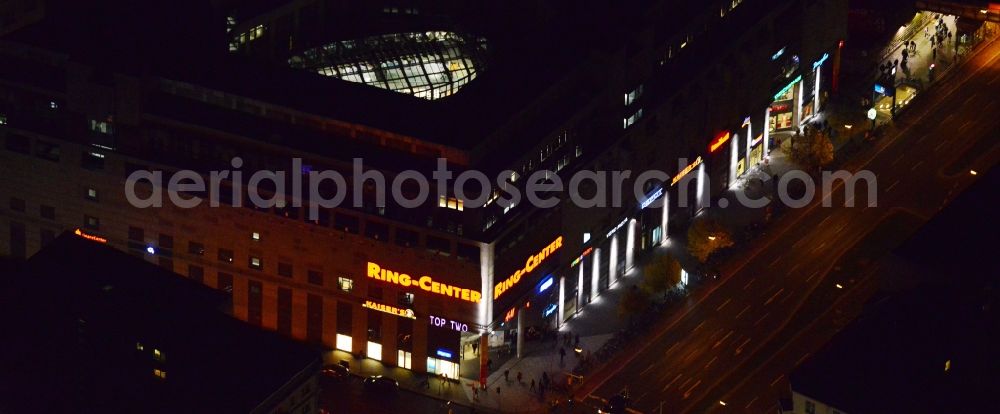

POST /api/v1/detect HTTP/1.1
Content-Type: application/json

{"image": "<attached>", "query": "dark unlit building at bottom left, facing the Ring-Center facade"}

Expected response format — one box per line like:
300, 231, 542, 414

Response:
0, 233, 320, 413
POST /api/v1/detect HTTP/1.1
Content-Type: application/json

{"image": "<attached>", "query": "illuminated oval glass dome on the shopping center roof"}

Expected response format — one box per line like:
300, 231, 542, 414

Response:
288, 32, 486, 99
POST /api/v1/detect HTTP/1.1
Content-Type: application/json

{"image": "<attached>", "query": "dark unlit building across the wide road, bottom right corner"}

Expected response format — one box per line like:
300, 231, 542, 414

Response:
791, 169, 1000, 413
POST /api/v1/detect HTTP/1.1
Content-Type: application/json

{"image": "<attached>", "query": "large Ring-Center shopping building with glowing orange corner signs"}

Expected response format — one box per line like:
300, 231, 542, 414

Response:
0, 0, 846, 384
